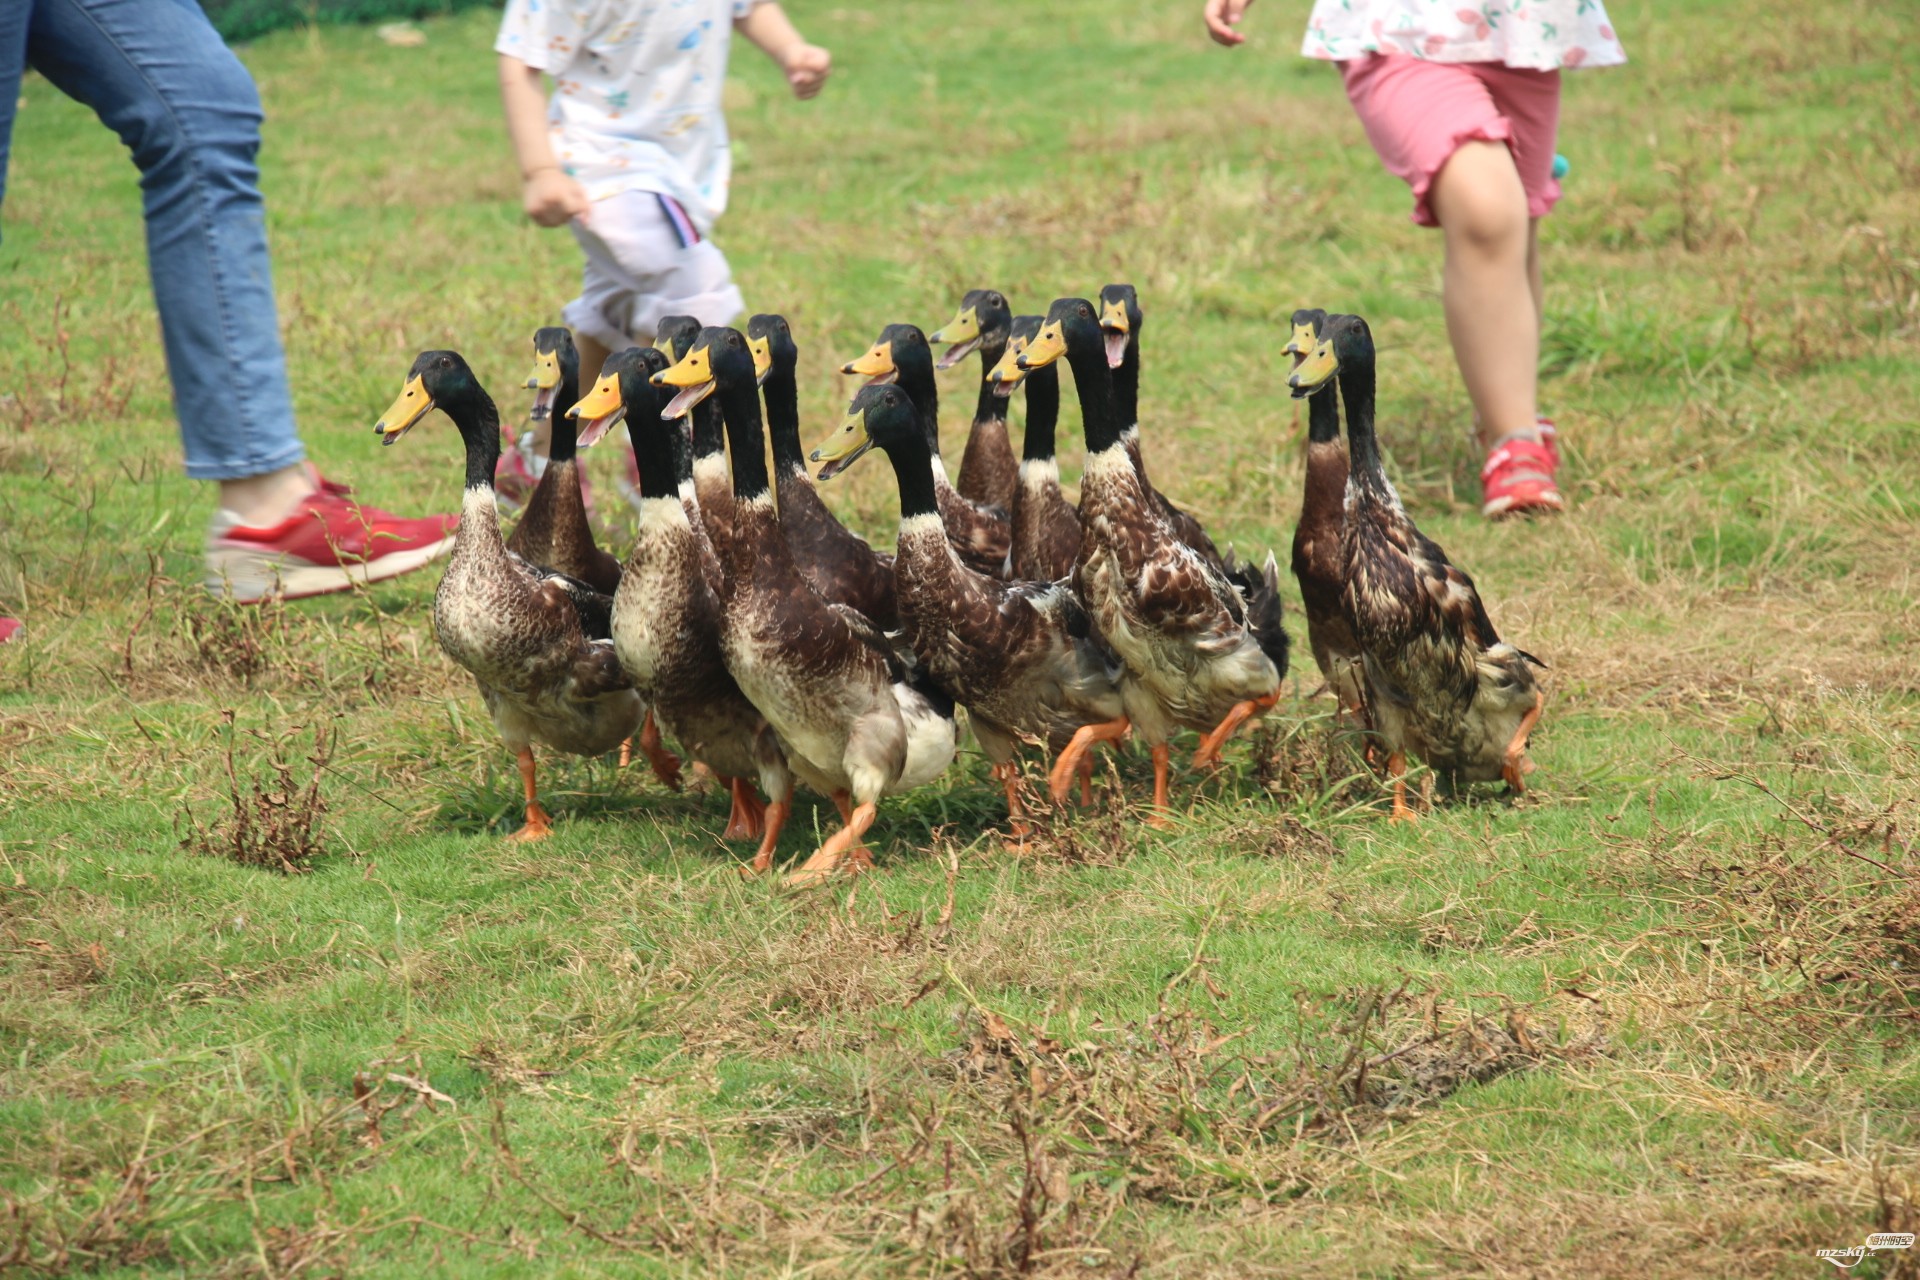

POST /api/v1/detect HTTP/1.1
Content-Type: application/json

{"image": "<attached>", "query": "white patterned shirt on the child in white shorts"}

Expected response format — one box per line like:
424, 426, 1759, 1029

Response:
493, 0, 760, 234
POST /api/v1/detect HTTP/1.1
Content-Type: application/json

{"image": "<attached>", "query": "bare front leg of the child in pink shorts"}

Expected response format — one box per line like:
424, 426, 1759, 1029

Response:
1432, 142, 1540, 449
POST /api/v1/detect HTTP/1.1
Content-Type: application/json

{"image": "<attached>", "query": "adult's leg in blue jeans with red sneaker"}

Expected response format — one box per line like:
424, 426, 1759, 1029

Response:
0, 0, 447, 599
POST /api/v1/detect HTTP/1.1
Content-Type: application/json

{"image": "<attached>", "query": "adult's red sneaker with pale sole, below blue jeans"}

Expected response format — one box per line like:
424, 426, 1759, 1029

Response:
207, 472, 459, 604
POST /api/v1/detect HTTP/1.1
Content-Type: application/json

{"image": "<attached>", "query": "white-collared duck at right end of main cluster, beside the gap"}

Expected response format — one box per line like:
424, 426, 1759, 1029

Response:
1018, 297, 1286, 821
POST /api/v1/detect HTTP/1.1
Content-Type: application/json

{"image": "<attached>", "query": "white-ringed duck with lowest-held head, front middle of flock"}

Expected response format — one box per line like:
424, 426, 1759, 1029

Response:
812, 386, 1123, 837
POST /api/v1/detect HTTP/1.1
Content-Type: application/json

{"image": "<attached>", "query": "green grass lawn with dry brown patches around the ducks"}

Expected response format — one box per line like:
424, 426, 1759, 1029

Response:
0, 0, 1920, 1278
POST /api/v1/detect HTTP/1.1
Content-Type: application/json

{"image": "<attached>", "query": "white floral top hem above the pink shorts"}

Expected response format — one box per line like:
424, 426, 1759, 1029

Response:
1300, 0, 1626, 71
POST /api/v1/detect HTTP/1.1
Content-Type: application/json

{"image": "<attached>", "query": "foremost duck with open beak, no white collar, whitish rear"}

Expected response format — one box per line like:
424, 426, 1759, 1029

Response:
653, 326, 956, 887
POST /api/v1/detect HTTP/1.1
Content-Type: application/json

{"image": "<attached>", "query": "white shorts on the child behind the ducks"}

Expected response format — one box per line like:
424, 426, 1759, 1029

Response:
563, 192, 747, 351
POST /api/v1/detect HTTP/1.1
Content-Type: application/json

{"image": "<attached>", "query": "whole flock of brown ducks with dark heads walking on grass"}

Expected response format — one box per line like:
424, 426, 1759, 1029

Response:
374, 284, 1542, 883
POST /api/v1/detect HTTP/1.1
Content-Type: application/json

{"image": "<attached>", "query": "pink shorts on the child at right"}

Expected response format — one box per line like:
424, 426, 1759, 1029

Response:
1340, 54, 1559, 226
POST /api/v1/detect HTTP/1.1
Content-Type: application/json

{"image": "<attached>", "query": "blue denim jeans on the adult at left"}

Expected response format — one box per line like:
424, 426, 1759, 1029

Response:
0, 0, 305, 480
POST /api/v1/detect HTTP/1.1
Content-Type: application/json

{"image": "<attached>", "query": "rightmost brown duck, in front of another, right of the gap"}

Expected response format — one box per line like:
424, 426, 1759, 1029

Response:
1288, 315, 1546, 823
